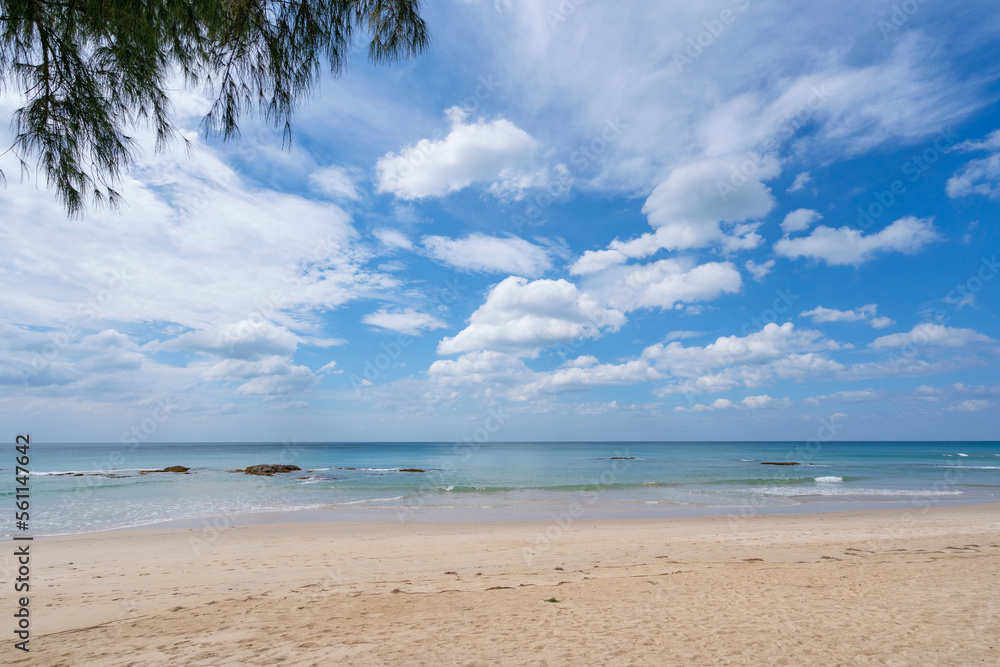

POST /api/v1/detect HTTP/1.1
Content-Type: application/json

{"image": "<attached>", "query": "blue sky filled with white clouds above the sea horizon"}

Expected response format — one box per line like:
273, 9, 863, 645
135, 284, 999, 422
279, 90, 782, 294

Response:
0, 0, 1000, 442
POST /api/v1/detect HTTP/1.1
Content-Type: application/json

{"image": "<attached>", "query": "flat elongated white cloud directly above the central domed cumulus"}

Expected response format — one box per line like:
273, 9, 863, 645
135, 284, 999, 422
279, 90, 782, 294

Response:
422, 234, 552, 278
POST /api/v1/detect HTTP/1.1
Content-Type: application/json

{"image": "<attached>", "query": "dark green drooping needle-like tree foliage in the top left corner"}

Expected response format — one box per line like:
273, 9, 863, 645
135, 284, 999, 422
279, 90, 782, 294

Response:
0, 0, 427, 215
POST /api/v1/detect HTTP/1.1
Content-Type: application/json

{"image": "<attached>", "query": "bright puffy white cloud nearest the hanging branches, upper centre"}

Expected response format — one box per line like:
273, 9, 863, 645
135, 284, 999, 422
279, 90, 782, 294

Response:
376, 107, 537, 199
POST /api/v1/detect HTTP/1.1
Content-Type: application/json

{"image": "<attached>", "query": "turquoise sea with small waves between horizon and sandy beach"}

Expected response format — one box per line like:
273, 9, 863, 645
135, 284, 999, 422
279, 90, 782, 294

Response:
0, 442, 1000, 535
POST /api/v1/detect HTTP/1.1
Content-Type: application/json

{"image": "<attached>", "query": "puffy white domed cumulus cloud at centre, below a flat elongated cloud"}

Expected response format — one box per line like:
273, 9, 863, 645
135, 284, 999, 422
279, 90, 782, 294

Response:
438, 276, 625, 356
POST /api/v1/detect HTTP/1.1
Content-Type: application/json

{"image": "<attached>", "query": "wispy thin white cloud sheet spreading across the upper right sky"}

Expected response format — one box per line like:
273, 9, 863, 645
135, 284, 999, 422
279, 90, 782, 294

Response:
472, 6, 992, 193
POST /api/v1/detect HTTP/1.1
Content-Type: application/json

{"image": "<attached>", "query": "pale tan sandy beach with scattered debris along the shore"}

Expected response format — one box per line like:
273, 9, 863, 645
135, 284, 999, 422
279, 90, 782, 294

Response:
7, 505, 1000, 666
